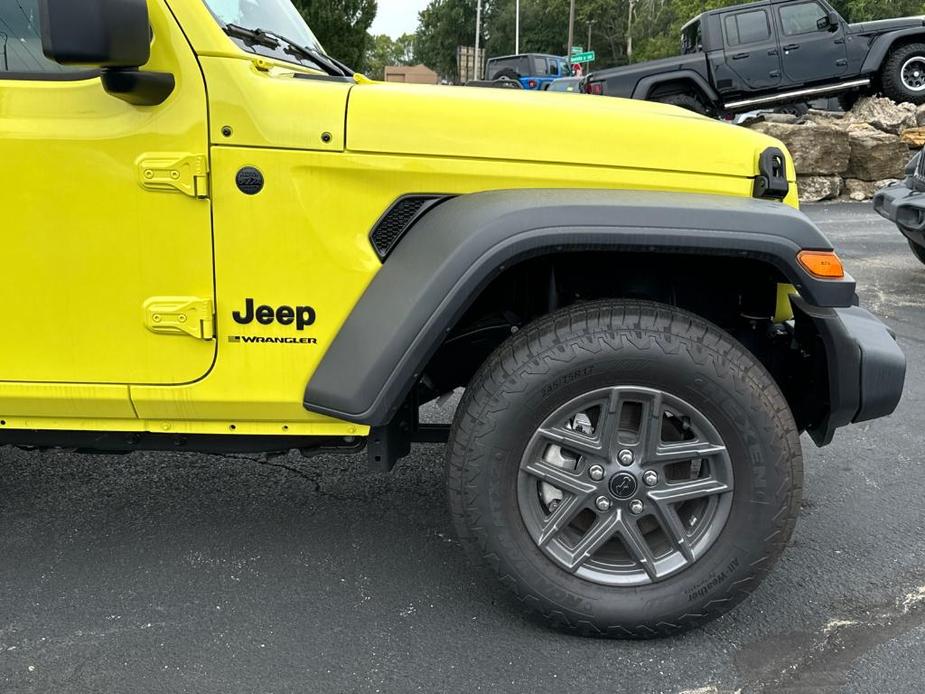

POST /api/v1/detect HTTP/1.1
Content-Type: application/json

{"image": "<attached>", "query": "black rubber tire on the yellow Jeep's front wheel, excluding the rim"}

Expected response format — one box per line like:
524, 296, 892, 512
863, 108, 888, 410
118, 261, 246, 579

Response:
447, 301, 803, 638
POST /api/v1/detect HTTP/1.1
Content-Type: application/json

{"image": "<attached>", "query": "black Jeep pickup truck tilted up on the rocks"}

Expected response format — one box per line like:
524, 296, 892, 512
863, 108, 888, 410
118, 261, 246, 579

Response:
585, 0, 925, 116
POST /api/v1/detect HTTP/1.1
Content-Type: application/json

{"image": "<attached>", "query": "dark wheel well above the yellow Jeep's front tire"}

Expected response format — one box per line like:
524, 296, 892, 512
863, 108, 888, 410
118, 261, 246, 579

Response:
417, 251, 806, 424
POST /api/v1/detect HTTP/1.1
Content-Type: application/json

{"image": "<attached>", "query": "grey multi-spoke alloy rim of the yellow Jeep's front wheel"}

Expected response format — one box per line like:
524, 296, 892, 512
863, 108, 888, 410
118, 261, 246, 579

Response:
517, 386, 733, 586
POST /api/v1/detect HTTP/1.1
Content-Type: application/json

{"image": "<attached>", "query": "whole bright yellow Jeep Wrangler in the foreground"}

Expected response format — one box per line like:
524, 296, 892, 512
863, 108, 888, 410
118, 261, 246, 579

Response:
0, 0, 905, 637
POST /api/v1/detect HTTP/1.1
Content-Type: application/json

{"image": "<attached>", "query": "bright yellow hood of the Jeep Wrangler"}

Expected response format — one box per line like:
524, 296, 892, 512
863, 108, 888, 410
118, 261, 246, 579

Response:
346, 82, 783, 177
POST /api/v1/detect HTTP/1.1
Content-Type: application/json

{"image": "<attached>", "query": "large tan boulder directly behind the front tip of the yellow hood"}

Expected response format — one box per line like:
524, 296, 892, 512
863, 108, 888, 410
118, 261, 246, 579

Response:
752, 122, 848, 176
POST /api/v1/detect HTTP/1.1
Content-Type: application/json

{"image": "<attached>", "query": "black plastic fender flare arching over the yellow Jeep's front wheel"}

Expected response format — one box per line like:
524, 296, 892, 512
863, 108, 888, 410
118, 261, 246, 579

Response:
304, 189, 855, 426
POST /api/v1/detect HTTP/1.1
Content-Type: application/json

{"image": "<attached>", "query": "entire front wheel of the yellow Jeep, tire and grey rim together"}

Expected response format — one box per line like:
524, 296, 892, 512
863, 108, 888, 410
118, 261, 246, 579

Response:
447, 301, 802, 638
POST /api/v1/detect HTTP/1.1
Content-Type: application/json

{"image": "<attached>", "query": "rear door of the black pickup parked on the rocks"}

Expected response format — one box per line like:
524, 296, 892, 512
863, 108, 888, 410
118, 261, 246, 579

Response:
722, 8, 781, 91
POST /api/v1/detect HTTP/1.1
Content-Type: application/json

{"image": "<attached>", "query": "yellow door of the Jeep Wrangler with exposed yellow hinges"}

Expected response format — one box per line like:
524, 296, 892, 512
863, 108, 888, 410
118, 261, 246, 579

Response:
0, 0, 215, 386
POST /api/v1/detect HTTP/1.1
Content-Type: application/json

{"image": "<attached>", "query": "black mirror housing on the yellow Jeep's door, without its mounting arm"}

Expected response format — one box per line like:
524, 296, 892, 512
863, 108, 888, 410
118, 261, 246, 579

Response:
39, 0, 151, 68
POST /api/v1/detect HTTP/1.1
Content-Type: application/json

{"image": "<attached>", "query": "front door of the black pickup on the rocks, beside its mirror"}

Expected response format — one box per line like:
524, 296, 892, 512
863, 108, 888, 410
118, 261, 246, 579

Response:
775, 0, 848, 84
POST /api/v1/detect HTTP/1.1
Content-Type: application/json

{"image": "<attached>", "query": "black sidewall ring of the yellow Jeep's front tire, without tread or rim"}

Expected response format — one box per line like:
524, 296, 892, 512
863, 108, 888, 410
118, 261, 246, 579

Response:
452, 304, 795, 629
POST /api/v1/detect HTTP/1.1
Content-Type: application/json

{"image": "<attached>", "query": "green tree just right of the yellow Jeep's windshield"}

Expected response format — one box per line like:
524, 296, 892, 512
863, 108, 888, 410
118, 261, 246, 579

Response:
294, 0, 377, 70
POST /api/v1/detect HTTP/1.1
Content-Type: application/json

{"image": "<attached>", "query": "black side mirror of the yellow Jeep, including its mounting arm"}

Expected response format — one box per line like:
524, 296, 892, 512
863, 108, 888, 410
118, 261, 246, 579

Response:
39, 0, 175, 106
